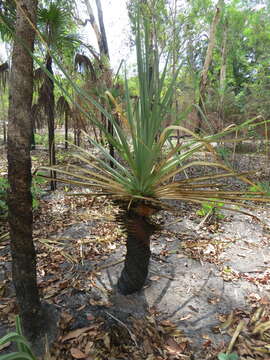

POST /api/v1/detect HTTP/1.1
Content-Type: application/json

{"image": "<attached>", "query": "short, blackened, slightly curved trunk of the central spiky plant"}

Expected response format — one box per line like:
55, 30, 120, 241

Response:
118, 211, 155, 295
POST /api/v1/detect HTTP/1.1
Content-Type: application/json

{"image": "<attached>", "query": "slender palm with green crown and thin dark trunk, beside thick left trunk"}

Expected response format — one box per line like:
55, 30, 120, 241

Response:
38, 2, 79, 190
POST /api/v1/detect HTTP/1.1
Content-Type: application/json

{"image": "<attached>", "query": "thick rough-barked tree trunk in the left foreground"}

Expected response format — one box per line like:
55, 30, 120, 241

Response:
8, 0, 43, 339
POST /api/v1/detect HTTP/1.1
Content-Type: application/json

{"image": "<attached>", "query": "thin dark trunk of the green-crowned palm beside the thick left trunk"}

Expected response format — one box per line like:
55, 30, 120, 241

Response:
46, 55, 56, 191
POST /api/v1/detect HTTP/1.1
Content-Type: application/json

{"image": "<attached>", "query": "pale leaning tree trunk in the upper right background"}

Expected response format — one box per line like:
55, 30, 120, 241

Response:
196, 0, 224, 133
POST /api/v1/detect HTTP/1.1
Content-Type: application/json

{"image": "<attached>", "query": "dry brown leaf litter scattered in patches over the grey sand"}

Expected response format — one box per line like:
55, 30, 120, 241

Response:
0, 150, 270, 360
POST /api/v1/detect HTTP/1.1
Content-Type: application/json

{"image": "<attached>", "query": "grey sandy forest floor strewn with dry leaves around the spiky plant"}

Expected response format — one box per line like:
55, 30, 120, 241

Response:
0, 147, 270, 360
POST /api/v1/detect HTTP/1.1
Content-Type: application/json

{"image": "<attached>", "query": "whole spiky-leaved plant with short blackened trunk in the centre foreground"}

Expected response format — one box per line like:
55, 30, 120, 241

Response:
40, 9, 267, 295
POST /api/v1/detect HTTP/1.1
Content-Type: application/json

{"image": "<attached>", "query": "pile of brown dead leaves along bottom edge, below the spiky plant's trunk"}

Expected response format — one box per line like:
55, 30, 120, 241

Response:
51, 312, 192, 360
